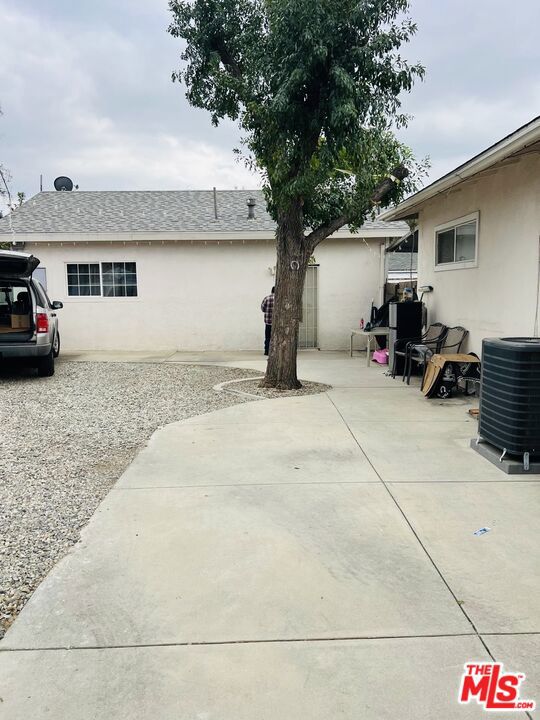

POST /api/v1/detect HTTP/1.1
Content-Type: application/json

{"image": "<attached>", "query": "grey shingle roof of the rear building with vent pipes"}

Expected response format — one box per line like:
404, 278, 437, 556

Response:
0, 190, 406, 234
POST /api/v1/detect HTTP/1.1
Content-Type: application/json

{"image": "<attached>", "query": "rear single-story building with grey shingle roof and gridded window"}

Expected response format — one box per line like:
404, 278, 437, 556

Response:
0, 190, 407, 352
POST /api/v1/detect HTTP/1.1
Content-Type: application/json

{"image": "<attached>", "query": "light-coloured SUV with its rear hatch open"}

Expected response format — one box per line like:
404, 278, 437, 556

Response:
0, 250, 63, 377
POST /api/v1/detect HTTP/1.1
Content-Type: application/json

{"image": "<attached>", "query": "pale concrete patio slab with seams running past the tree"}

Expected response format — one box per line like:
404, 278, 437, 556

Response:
0, 352, 540, 720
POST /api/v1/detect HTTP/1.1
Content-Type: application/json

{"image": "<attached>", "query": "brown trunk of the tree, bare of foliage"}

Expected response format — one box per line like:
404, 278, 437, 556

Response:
261, 204, 311, 390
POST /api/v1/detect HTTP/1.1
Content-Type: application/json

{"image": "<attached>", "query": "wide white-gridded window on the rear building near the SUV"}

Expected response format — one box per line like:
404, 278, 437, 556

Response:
66, 262, 137, 297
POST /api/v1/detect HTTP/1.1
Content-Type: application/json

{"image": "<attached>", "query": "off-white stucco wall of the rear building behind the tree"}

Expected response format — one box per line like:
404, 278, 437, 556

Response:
25, 237, 384, 352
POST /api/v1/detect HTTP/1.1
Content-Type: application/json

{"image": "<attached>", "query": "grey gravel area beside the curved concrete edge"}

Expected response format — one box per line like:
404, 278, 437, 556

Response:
0, 362, 274, 637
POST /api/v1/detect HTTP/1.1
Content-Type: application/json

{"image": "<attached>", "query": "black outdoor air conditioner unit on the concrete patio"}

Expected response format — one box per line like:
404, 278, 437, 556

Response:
479, 337, 540, 470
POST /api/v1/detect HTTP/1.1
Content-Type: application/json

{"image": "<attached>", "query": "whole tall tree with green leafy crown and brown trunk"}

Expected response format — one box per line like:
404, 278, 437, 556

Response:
169, 0, 424, 387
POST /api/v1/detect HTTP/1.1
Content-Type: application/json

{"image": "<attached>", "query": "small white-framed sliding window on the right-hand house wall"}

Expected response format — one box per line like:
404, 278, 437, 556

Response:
435, 212, 479, 270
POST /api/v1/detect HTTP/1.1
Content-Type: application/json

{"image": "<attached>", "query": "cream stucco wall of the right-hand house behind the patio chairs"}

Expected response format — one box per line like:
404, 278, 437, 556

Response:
418, 154, 540, 354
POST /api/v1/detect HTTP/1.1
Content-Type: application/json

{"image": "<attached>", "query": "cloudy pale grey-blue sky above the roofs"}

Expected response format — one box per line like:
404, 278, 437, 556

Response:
0, 0, 540, 207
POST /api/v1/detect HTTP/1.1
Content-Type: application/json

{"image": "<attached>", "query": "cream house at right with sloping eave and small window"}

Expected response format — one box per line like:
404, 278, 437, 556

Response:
380, 117, 540, 354
